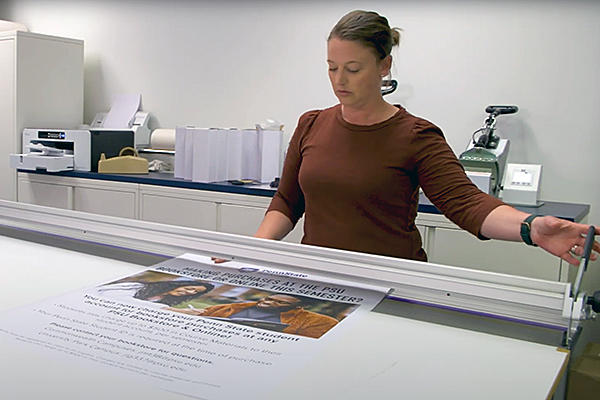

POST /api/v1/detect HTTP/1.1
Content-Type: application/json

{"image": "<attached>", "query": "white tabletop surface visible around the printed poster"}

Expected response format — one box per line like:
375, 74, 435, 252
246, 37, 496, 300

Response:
0, 236, 568, 400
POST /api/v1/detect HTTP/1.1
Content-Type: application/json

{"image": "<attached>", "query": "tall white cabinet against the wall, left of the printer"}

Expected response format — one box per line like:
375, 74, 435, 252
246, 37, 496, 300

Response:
0, 31, 83, 200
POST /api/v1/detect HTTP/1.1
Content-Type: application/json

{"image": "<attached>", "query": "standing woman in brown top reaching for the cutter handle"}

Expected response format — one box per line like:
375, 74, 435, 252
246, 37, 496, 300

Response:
255, 11, 600, 265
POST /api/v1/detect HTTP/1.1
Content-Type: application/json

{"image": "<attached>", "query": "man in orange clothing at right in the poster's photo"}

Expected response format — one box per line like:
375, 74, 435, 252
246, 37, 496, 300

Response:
174, 294, 338, 338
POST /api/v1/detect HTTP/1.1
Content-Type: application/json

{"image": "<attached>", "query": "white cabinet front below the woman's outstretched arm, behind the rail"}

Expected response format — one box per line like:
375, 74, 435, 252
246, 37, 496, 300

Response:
429, 228, 561, 281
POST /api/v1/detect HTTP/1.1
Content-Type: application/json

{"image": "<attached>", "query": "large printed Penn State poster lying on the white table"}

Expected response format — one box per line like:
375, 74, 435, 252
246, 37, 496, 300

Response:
0, 254, 388, 399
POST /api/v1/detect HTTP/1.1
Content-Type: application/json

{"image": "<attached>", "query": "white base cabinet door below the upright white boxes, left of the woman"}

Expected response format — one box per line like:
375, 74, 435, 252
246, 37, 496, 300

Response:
140, 191, 217, 231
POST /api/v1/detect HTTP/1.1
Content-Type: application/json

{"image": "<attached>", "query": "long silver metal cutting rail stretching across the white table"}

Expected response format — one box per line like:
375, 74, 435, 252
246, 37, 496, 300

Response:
0, 200, 579, 332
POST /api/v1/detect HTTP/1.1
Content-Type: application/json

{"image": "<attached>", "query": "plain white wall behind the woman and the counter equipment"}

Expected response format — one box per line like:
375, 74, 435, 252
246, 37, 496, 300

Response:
0, 0, 600, 223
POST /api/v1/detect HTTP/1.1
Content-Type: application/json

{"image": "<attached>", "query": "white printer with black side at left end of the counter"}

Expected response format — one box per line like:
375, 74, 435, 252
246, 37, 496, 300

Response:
10, 129, 134, 172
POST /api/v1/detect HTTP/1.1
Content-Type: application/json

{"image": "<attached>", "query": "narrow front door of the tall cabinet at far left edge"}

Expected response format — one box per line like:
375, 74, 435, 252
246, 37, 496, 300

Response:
0, 38, 15, 201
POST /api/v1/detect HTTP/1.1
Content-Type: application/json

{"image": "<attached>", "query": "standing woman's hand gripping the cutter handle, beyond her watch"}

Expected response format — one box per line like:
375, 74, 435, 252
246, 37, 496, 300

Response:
531, 216, 600, 266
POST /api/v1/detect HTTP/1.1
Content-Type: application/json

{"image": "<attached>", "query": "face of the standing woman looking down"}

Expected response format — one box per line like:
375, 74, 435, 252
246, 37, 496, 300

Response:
327, 38, 391, 107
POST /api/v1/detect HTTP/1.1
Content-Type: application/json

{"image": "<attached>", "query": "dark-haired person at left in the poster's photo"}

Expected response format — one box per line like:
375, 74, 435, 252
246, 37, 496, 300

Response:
97, 280, 214, 306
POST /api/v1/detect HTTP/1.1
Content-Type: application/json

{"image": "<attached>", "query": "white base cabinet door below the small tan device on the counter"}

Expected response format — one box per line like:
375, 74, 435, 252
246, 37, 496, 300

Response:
73, 186, 137, 218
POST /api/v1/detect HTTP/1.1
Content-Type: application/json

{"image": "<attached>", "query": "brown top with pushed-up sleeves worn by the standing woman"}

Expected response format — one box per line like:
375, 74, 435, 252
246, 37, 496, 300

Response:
267, 105, 504, 261
